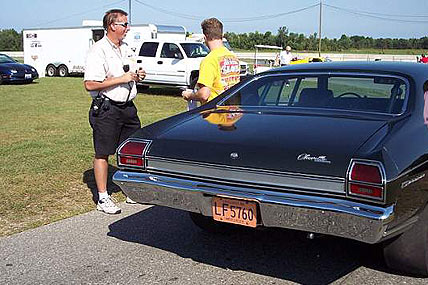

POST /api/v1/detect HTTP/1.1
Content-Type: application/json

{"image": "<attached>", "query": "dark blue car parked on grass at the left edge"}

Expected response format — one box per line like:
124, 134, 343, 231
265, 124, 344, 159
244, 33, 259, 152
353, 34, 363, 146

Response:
0, 53, 39, 84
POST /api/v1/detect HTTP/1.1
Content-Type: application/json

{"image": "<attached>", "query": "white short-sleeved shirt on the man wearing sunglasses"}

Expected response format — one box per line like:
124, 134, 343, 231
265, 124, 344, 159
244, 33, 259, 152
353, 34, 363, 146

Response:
84, 36, 137, 102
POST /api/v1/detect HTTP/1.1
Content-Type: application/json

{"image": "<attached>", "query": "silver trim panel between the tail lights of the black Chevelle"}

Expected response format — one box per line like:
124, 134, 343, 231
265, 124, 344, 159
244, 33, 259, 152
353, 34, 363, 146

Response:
147, 156, 346, 194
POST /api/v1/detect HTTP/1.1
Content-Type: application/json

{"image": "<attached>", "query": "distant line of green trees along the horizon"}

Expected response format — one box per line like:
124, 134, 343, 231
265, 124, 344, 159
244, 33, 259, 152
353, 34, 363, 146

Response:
0, 26, 428, 52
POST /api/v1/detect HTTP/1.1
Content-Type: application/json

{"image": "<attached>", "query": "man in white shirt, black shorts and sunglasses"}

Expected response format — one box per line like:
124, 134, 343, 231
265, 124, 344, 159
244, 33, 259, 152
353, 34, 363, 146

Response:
84, 9, 145, 214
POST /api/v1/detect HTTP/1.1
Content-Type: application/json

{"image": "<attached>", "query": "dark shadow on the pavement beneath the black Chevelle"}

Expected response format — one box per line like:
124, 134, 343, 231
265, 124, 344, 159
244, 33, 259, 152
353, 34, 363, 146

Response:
108, 206, 386, 284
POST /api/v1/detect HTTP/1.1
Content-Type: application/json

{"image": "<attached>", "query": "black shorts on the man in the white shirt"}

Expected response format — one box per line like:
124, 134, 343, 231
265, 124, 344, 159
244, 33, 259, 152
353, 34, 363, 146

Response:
89, 102, 141, 156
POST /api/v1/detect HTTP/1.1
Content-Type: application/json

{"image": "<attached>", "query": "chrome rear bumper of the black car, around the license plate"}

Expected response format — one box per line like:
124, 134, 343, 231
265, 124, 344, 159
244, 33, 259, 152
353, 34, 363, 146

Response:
113, 171, 394, 243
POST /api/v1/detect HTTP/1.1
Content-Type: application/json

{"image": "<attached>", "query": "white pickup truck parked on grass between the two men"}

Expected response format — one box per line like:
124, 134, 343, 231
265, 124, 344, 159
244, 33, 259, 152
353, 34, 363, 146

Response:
137, 40, 247, 89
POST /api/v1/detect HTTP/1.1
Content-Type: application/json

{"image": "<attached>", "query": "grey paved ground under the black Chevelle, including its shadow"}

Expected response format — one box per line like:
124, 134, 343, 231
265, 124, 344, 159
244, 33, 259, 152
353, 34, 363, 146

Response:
0, 204, 428, 285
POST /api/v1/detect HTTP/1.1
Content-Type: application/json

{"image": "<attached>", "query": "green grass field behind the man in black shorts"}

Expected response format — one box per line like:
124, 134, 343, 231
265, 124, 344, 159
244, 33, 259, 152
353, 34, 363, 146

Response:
0, 77, 186, 236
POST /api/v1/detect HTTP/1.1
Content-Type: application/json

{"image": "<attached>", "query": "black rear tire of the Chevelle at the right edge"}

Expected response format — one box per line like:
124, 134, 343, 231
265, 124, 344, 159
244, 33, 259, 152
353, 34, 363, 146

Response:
383, 202, 428, 277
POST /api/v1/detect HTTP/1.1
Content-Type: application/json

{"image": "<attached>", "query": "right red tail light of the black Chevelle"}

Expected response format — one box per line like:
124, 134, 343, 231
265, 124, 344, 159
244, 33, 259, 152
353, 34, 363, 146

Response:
348, 160, 386, 201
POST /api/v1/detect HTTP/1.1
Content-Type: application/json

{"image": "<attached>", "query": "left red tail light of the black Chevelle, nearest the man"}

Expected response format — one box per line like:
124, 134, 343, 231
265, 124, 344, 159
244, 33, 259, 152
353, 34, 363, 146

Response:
117, 139, 151, 169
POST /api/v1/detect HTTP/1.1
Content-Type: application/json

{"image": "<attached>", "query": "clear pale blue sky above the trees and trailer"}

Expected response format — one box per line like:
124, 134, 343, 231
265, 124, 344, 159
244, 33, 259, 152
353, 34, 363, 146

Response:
0, 0, 428, 38
